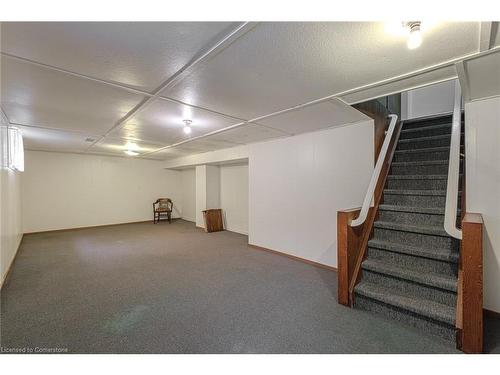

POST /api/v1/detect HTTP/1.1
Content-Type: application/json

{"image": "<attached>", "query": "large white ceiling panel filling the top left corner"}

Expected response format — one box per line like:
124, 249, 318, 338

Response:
0, 22, 235, 91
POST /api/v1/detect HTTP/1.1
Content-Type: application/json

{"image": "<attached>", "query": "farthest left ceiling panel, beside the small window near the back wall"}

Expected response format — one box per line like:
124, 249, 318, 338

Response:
16, 126, 93, 152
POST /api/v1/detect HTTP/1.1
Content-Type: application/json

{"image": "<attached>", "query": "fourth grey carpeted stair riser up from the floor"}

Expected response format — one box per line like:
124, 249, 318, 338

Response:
373, 228, 458, 251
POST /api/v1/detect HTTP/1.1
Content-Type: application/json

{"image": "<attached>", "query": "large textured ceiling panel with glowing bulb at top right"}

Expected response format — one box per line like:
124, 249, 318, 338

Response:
163, 22, 479, 119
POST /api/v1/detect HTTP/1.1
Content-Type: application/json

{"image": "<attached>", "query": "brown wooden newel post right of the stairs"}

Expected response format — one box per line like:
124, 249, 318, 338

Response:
456, 212, 484, 353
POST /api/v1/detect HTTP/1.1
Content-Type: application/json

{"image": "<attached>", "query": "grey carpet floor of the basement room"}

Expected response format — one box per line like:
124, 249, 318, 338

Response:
0, 220, 500, 353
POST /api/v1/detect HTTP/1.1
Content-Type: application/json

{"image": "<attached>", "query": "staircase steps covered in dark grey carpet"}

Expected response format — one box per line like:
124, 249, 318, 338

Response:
354, 115, 463, 341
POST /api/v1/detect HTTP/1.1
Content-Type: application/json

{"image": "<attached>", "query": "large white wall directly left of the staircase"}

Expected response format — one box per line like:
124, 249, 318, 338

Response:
249, 120, 374, 267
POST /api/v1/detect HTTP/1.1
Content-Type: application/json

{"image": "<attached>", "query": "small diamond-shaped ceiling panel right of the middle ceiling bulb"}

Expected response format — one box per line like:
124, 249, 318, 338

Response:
208, 124, 290, 144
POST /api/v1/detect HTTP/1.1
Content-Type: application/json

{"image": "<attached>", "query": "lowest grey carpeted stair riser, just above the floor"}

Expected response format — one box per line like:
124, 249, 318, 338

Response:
354, 294, 455, 345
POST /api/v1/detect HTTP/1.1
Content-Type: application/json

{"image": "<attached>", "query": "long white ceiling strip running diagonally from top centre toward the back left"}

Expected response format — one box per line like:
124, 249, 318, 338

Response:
88, 22, 257, 149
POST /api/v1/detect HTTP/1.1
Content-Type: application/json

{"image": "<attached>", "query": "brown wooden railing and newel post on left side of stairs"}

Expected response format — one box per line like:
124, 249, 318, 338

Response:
337, 101, 402, 306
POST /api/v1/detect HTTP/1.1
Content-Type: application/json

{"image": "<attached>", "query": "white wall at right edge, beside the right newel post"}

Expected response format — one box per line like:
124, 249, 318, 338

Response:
465, 97, 500, 312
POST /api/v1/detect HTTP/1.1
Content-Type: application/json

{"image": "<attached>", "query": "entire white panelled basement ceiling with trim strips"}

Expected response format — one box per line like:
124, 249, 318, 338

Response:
0, 22, 499, 160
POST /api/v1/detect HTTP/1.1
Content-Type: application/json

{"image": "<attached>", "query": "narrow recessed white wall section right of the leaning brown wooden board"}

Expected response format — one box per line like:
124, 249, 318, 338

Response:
220, 164, 248, 234
